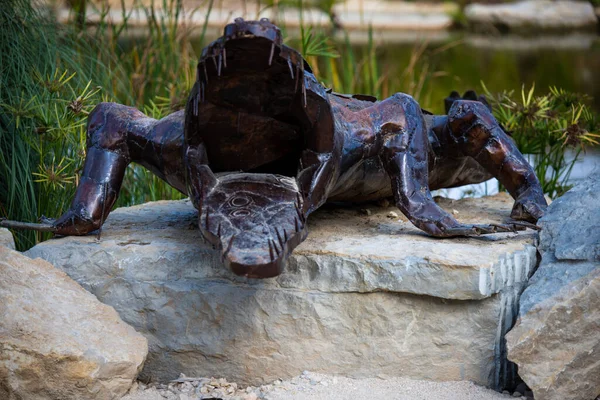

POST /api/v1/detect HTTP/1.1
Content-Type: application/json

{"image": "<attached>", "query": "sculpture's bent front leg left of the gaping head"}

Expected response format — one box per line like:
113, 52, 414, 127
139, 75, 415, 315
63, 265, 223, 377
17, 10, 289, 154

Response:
52, 103, 185, 235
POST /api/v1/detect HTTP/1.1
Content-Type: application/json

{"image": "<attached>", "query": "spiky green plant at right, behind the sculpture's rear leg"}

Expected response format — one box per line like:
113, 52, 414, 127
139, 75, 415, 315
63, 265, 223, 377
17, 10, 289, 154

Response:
482, 83, 600, 198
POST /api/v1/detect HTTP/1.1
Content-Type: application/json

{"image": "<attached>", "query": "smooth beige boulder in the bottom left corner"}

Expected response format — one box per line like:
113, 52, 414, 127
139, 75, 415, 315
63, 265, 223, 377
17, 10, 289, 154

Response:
0, 247, 148, 400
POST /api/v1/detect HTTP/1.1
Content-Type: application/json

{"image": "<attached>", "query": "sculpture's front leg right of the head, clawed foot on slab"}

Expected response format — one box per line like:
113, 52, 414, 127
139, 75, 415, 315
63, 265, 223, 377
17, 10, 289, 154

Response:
380, 93, 514, 237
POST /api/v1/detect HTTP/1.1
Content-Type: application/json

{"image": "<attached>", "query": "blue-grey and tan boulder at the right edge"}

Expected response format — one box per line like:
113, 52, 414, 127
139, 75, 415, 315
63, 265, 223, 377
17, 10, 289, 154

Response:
507, 174, 600, 400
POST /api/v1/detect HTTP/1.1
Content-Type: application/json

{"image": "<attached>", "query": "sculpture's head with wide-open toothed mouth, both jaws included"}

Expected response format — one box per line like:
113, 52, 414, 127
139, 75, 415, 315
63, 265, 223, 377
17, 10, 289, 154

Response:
185, 18, 342, 278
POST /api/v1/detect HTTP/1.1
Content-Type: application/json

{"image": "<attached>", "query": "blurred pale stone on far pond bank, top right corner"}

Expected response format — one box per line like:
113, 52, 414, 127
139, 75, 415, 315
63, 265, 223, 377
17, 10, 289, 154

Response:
465, 0, 598, 30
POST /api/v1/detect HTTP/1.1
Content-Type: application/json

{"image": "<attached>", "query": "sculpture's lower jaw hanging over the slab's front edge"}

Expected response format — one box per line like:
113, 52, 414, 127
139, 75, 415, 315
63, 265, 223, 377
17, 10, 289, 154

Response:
199, 173, 308, 278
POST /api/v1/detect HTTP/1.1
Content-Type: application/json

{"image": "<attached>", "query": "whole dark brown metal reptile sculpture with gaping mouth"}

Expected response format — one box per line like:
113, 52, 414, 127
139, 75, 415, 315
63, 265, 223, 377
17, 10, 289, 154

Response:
4, 18, 547, 278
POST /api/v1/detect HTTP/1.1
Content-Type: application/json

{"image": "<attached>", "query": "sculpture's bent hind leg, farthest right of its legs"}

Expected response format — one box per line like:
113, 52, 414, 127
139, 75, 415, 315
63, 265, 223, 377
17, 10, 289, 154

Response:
438, 100, 547, 222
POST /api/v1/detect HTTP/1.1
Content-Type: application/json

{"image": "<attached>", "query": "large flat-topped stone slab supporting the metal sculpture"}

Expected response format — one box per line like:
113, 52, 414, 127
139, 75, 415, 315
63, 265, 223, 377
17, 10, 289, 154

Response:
28, 195, 536, 387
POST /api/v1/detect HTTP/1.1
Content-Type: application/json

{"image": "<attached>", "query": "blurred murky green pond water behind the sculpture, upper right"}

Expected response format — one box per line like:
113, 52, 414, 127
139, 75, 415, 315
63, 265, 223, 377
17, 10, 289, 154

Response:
344, 32, 600, 113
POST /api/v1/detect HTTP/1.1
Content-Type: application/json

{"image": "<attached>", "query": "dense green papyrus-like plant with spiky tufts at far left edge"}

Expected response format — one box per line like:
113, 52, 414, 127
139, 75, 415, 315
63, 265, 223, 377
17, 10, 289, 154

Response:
0, 0, 108, 248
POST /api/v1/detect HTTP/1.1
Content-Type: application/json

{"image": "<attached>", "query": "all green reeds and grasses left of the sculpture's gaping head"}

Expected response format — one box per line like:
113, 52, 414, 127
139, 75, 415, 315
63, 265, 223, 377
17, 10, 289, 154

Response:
0, 0, 197, 249
